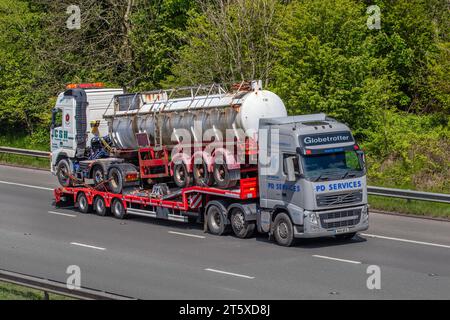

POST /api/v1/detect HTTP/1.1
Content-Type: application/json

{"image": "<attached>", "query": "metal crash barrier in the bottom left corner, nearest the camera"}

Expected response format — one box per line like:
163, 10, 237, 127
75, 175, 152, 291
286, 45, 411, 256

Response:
0, 270, 136, 300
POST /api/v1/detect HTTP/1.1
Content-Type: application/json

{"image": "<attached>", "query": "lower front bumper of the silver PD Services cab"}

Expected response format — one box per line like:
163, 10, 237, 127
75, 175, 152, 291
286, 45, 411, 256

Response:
294, 205, 369, 238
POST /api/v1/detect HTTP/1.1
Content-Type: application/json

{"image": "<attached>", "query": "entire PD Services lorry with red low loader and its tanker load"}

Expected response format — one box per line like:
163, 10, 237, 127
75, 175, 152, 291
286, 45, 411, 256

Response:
51, 82, 369, 246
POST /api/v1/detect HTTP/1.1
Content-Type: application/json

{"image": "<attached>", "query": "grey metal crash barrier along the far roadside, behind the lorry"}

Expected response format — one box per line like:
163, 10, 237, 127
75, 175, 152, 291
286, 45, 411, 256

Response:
0, 146, 450, 203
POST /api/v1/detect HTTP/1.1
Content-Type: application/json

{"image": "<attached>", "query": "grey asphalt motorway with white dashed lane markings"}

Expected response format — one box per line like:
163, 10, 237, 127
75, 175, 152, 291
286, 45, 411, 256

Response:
0, 166, 450, 299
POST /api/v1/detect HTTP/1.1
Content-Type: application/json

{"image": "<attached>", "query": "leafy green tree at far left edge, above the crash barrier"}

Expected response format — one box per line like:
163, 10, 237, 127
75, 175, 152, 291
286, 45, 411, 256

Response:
0, 0, 48, 134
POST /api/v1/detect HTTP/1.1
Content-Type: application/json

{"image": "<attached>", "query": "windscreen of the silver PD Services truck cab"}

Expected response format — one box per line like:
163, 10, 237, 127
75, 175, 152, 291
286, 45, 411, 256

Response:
301, 151, 364, 181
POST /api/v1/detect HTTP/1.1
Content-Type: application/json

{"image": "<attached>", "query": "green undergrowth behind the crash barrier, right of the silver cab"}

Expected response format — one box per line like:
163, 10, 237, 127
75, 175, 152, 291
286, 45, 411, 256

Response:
362, 111, 450, 192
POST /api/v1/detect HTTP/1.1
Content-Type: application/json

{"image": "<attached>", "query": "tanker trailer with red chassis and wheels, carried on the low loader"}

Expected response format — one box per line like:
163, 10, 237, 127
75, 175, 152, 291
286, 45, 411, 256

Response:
103, 81, 287, 189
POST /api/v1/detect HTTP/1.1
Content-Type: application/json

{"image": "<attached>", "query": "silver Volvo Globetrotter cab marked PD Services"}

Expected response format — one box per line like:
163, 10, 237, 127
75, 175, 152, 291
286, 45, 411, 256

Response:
259, 114, 369, 245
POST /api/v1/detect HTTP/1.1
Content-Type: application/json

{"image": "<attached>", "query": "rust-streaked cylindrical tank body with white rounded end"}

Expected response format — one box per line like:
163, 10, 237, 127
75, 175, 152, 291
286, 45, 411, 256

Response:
104, 84, 287, 149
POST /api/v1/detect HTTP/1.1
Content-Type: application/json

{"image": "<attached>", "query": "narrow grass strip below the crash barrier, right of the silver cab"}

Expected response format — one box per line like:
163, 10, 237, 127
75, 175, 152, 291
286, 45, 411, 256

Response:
369, 196, 450, 219
